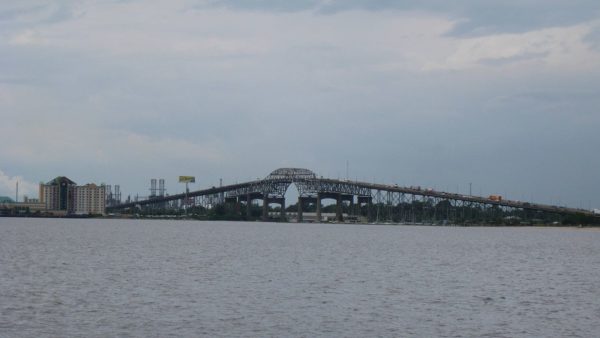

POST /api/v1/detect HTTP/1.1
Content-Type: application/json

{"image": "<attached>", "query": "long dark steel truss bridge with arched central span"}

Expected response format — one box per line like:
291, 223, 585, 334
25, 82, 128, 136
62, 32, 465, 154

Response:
107, 168, 599, 222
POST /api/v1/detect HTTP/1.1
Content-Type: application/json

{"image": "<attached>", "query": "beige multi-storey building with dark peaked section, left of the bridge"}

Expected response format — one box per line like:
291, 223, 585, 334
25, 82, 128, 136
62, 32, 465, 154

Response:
40, 176, 106, 215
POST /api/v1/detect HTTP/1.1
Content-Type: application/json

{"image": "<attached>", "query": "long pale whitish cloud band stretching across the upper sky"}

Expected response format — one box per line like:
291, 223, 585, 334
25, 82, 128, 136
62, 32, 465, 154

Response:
5, 1, 597, 80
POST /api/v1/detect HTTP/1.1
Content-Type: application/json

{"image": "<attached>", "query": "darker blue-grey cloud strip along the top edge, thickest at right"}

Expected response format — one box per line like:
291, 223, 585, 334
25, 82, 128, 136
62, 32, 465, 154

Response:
202, 0, 600, 36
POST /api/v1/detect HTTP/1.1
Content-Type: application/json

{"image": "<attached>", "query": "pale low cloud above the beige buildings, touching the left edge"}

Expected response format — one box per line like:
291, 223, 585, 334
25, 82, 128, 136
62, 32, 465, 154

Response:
0, 120, 224, 171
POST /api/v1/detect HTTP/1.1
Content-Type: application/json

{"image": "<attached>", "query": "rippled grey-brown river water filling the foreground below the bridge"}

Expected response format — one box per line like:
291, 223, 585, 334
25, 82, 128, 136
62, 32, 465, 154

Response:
0, 218, 600, 337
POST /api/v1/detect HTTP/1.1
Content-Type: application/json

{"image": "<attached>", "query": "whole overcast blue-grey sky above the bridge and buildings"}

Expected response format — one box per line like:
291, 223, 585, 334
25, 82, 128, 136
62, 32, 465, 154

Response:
0, 0, 600, 209
